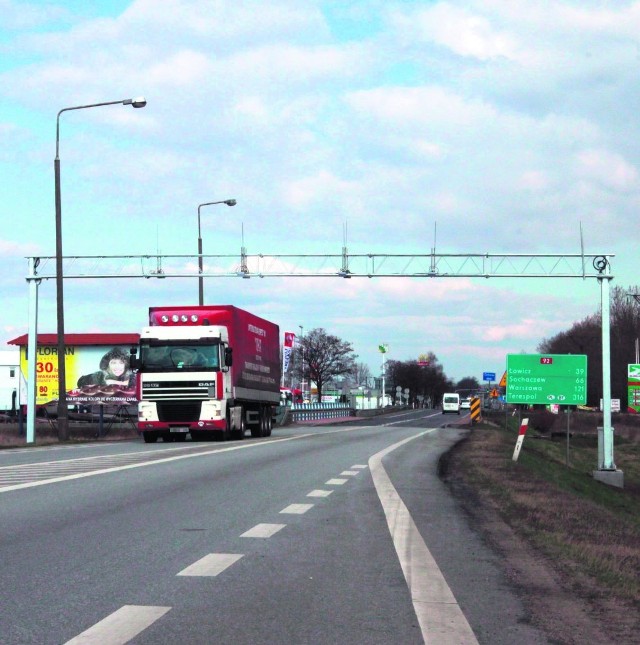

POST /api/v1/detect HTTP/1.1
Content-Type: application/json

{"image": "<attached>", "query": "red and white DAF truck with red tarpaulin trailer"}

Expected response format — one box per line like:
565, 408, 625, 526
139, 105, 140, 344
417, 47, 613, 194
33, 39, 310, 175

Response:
131, 305, 280, 443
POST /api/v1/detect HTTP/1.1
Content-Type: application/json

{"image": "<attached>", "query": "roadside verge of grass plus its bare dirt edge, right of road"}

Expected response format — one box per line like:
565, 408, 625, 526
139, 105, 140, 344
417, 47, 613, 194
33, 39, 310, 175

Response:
443, 417, 640, 642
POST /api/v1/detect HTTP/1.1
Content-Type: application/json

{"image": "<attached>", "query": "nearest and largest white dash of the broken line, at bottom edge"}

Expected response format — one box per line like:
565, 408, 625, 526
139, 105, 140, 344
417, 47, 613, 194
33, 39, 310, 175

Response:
65, 605, 171, 645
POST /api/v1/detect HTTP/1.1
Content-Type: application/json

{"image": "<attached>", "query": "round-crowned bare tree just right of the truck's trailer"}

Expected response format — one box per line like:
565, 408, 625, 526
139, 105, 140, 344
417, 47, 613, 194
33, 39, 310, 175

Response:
301, 327, 358, 401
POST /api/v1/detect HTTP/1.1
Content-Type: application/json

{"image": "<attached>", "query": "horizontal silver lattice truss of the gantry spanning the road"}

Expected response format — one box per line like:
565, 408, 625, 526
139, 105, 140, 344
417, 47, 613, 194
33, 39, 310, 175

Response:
27, 248, 614, 280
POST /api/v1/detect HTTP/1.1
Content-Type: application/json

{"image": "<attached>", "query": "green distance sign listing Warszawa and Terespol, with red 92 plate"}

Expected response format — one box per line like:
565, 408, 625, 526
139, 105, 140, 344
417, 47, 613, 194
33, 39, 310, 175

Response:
507, 354, 587, 405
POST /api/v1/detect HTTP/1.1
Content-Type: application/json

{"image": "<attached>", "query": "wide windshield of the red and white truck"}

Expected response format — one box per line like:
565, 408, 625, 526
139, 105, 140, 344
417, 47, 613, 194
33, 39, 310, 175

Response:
140, 341, 220, 372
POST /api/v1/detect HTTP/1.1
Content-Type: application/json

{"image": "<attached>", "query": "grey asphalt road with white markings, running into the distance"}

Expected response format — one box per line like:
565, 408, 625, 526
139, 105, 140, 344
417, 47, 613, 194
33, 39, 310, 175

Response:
0, 410, 547, 645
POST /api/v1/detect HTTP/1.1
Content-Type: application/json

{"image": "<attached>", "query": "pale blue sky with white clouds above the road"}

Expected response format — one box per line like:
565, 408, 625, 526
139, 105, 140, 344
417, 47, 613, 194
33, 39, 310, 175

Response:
0, 0, 640, 381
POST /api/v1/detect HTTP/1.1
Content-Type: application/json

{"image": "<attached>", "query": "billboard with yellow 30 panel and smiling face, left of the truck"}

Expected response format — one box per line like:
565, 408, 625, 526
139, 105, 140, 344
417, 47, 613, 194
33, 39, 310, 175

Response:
20, 345, 136, 405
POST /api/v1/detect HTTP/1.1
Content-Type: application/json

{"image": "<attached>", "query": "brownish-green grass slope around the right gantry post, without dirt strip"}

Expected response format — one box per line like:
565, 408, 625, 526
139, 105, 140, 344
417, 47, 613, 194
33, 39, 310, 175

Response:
455, 416, 640, 607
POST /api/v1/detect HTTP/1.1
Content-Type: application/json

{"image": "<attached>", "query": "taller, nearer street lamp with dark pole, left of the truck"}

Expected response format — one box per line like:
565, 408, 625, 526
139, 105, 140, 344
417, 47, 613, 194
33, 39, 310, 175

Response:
55, 96, 147, 440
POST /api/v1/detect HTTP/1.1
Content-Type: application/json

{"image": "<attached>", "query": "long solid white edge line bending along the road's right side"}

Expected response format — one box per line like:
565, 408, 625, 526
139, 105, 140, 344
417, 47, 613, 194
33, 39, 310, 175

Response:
369, 428, 478, 645
